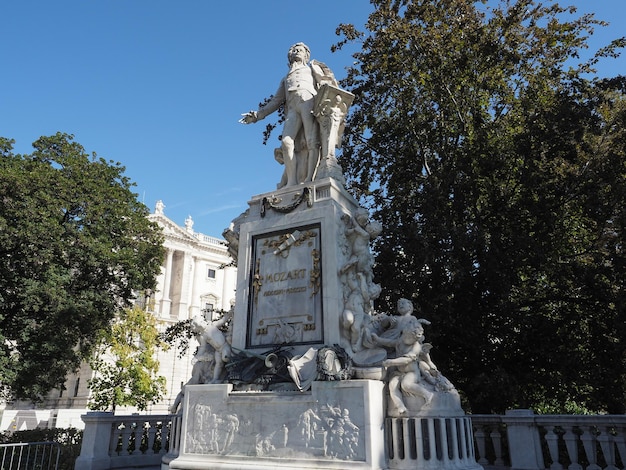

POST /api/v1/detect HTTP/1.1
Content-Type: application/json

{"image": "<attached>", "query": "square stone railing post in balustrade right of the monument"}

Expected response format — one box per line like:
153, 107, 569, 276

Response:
502, 410, 545, 470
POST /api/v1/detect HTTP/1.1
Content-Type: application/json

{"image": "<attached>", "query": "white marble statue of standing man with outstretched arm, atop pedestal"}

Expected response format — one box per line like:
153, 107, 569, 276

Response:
239, 42, 337, 186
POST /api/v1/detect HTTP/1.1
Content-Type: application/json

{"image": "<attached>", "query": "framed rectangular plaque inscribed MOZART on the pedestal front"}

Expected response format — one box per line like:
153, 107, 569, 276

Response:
246, 224, 324, 348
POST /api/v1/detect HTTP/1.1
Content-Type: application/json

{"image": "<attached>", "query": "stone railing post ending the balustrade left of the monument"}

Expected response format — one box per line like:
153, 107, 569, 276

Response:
74, 412, 113, 470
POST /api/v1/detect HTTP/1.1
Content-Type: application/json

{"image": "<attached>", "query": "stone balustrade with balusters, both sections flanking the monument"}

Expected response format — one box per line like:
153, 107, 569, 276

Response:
75, 410, 626, 470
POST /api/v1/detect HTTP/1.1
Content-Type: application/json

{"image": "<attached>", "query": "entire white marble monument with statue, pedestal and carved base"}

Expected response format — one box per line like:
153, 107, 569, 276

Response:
169, 43, 481, 470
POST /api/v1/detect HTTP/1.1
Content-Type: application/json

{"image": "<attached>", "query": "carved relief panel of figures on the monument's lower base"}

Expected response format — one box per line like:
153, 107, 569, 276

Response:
184, 394, 365, 461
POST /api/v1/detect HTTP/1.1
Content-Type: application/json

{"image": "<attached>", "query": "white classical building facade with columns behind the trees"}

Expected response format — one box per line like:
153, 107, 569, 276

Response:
0, 201, 237, 432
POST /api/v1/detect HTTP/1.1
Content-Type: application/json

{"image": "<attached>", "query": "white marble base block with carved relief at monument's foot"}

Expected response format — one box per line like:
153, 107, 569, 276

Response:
169, 380, 387, 470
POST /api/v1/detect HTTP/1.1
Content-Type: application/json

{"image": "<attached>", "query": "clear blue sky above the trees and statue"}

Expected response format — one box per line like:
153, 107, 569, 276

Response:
0, 0, 626, 237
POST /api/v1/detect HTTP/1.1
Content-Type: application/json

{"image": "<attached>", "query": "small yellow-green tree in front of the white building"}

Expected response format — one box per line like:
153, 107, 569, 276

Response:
88, 307, 166, 411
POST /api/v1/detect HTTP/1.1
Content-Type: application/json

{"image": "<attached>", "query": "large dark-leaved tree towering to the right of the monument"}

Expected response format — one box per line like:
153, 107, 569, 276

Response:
336, 0, 626, 413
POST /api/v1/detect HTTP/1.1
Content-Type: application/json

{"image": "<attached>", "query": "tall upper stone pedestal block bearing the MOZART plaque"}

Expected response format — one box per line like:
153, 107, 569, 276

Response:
232, 178, 357, 355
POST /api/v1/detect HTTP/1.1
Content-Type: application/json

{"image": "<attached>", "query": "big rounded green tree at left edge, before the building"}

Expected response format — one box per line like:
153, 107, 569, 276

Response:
0, 133, 164, 401
